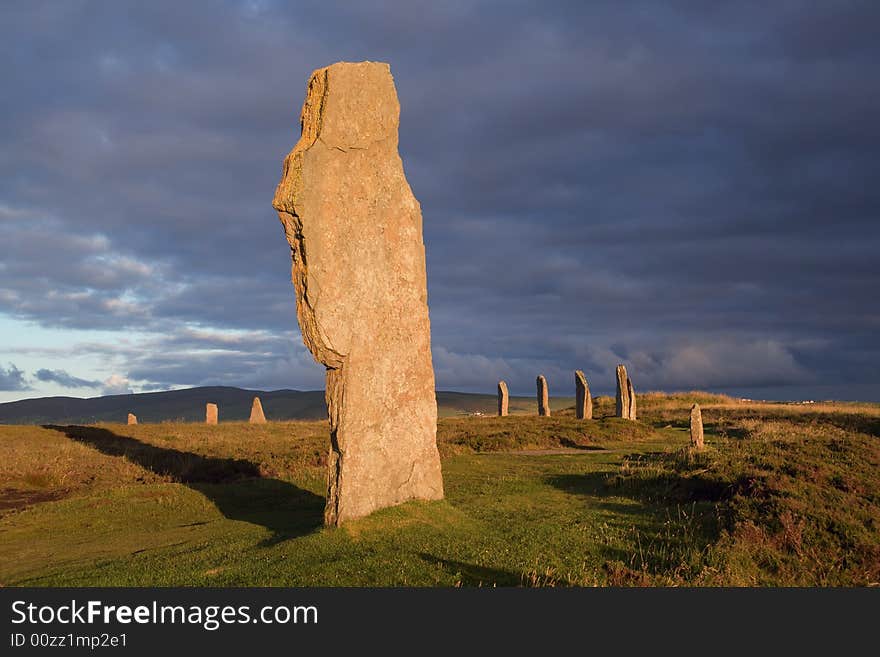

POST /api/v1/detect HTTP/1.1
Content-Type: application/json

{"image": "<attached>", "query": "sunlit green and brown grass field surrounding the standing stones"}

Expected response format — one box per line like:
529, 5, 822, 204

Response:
0, 393, 880, 586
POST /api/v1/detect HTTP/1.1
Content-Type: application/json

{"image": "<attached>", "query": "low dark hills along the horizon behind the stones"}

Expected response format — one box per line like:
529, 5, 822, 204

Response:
0, 386, 574, 424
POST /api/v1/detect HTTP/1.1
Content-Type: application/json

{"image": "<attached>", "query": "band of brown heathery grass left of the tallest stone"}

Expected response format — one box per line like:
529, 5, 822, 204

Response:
0, 422, 327, 512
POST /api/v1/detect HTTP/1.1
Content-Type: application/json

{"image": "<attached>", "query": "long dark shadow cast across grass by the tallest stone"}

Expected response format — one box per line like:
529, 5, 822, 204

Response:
44, 425, 324, 545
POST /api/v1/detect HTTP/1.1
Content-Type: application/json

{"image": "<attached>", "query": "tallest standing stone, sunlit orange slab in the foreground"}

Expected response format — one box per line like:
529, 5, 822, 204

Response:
272, 62, 443, 525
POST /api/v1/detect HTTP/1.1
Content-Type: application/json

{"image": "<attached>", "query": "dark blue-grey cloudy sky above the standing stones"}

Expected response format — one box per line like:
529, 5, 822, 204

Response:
0, 0, 880, 402
